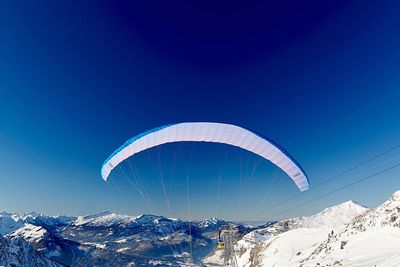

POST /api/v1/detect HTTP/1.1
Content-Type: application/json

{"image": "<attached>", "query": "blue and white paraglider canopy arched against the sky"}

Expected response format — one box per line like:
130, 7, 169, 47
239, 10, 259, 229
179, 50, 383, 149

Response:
101, 122, 309, 191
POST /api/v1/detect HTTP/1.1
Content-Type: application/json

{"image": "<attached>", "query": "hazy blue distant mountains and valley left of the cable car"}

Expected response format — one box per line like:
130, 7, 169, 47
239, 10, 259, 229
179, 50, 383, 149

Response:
0, 212, 254, 266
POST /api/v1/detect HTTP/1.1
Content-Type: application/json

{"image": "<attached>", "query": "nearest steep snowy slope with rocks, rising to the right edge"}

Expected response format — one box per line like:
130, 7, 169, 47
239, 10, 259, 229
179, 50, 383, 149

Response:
304, 191, 400, 266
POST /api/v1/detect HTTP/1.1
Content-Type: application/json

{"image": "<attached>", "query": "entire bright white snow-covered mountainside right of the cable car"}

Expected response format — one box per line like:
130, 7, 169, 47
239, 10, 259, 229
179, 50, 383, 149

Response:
228, 191, 400, 267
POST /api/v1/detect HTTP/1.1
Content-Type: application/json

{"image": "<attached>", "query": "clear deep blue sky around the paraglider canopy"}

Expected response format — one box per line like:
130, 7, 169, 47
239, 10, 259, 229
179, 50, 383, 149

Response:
0, 1, 400, 219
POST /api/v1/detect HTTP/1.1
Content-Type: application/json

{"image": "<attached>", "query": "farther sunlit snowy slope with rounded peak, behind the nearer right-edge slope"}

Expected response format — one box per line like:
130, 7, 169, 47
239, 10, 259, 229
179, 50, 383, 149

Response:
231, 201, 368, 266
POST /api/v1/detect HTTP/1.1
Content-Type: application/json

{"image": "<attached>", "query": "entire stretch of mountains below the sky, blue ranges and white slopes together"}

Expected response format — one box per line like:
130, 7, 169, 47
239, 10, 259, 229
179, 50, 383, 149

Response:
0, 191, 400, 267
